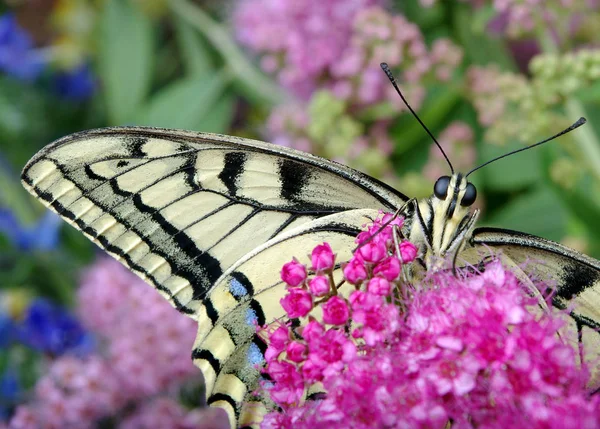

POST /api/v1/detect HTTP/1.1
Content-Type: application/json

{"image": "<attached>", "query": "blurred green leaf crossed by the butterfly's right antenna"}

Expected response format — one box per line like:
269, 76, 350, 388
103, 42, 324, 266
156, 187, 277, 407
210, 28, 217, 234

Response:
478, 142, 544, 191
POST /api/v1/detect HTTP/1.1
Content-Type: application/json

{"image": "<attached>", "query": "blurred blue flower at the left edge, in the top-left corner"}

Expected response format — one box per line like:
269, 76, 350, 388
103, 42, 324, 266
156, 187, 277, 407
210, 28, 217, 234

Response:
0, 13, 46, 81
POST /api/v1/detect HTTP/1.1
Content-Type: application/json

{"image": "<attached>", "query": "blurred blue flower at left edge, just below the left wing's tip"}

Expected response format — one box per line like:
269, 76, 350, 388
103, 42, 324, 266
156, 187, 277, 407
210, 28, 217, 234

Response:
0, 208, 62, 251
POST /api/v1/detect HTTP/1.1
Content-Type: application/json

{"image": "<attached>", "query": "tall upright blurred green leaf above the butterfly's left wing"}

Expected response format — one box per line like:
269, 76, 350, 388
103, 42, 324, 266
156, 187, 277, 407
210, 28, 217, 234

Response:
98, 0, 154, 125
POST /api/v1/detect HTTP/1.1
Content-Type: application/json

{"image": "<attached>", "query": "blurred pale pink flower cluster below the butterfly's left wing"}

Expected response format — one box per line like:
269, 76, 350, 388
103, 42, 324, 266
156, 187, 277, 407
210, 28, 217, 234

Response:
9, 258, 209, 429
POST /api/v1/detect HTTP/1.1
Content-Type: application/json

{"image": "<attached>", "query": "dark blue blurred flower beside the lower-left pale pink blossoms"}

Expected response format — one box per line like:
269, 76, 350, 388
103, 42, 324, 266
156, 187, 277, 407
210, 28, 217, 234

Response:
17, 298, 94, 356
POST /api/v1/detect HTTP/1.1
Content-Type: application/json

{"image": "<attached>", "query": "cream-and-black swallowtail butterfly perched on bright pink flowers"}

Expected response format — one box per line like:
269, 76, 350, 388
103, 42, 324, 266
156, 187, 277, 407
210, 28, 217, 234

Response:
22, 67, 600, 427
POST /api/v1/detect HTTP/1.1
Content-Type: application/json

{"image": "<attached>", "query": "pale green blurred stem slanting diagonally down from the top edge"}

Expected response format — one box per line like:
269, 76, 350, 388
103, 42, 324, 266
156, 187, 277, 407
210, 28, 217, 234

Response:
169, 0, 289, 105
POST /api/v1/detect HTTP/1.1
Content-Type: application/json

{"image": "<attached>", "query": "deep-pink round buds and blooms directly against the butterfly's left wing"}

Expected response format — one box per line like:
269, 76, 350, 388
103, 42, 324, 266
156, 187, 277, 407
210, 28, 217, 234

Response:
261, 215, 416, 414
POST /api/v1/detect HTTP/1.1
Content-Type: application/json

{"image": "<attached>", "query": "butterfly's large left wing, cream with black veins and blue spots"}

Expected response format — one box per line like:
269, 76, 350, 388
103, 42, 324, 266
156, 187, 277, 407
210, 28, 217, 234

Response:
22, 127, 407, 424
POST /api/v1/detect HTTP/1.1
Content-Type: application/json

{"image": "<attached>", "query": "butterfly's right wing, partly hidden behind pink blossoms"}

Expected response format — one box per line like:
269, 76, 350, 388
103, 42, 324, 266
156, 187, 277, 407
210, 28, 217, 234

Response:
471, 228, 600, 390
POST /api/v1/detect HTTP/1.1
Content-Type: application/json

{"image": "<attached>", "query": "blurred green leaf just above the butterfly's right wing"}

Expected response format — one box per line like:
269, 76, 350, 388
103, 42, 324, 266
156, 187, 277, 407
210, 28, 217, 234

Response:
482, 186, 568, 241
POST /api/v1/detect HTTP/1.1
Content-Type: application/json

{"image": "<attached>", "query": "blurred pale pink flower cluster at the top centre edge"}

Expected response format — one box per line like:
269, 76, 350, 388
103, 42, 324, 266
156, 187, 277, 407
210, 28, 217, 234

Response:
234, 0, 380, 98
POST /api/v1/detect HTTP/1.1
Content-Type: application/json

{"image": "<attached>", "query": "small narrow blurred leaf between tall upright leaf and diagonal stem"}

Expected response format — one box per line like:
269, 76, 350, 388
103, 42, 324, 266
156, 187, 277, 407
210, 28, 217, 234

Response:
175, 18, 214, 76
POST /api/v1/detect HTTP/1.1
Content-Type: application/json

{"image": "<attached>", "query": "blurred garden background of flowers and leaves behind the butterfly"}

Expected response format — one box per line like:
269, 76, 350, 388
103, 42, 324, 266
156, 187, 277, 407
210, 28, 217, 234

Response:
0, 0, 600, 428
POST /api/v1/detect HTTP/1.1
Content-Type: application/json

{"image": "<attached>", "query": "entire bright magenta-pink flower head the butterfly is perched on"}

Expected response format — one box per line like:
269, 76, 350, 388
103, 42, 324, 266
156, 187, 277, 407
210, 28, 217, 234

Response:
261, 215, 600, 429
